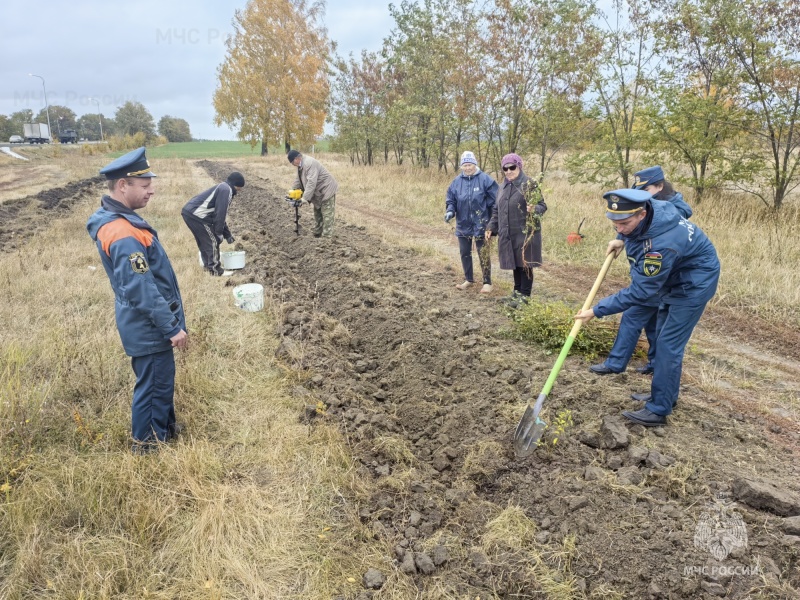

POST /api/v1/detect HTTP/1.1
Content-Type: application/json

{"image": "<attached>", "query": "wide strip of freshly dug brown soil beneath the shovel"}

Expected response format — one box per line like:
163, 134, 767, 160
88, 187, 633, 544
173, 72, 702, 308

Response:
202, 163, 800, 598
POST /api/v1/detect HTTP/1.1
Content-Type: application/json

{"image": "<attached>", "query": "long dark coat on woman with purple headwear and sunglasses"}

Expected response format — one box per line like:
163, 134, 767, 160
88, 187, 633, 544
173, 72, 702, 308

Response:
487, 171, 547, 269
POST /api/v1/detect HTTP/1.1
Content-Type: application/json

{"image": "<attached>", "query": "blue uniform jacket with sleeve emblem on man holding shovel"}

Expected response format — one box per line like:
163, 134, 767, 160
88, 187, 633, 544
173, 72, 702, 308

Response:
593, 200, 720, 317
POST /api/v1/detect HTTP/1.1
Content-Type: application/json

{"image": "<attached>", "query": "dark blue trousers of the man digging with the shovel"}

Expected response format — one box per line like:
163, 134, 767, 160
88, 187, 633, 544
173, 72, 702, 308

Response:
645, 302, 706, 416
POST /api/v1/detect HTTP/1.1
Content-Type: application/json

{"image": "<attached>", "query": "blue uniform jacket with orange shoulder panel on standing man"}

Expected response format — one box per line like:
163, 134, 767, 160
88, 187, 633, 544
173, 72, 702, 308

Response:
86, 196, 186, 356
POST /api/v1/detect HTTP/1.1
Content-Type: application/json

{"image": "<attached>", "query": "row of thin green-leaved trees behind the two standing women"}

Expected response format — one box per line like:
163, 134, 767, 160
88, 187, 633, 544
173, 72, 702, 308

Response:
329, 0, 800, 207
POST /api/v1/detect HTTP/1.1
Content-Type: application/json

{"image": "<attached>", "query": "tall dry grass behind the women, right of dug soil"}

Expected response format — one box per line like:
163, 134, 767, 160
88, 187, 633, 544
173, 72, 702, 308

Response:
268, 155, 800, 327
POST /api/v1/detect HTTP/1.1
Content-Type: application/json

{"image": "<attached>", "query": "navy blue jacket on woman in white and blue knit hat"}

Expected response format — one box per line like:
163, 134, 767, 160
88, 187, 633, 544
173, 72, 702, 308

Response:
445, 169, 497, 238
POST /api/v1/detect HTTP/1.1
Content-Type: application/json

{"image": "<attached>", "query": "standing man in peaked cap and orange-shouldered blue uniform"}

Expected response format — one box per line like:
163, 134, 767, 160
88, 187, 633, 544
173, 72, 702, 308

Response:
86, 148, 188, 453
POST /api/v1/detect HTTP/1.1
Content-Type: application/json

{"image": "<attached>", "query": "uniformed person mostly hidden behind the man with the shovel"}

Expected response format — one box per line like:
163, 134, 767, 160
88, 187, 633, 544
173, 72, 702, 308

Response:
589, 165, 692, 375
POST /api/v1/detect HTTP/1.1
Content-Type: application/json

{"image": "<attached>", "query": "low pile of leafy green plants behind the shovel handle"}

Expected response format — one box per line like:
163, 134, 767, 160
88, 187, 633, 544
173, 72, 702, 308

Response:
507, 298, 617, 358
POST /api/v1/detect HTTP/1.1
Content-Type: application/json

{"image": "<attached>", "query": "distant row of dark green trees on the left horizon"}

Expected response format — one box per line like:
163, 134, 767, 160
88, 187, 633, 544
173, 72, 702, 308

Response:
0, 101, 192, 142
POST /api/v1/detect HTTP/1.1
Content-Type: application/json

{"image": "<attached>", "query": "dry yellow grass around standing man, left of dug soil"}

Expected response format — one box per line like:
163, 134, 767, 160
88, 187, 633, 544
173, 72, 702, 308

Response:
0, 157, 411, 599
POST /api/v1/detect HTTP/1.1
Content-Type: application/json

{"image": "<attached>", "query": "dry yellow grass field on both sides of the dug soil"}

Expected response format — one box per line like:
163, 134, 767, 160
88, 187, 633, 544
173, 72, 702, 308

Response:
0, 148, 800, 600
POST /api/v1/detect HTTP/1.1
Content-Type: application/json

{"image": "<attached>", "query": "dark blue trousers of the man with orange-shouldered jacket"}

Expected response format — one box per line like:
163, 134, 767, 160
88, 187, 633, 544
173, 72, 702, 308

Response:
131, 348, 175, 444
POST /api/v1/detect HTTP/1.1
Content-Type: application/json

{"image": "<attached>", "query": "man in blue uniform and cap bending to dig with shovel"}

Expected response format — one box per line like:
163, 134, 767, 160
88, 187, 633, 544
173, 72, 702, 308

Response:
575, 189, 720, 427
